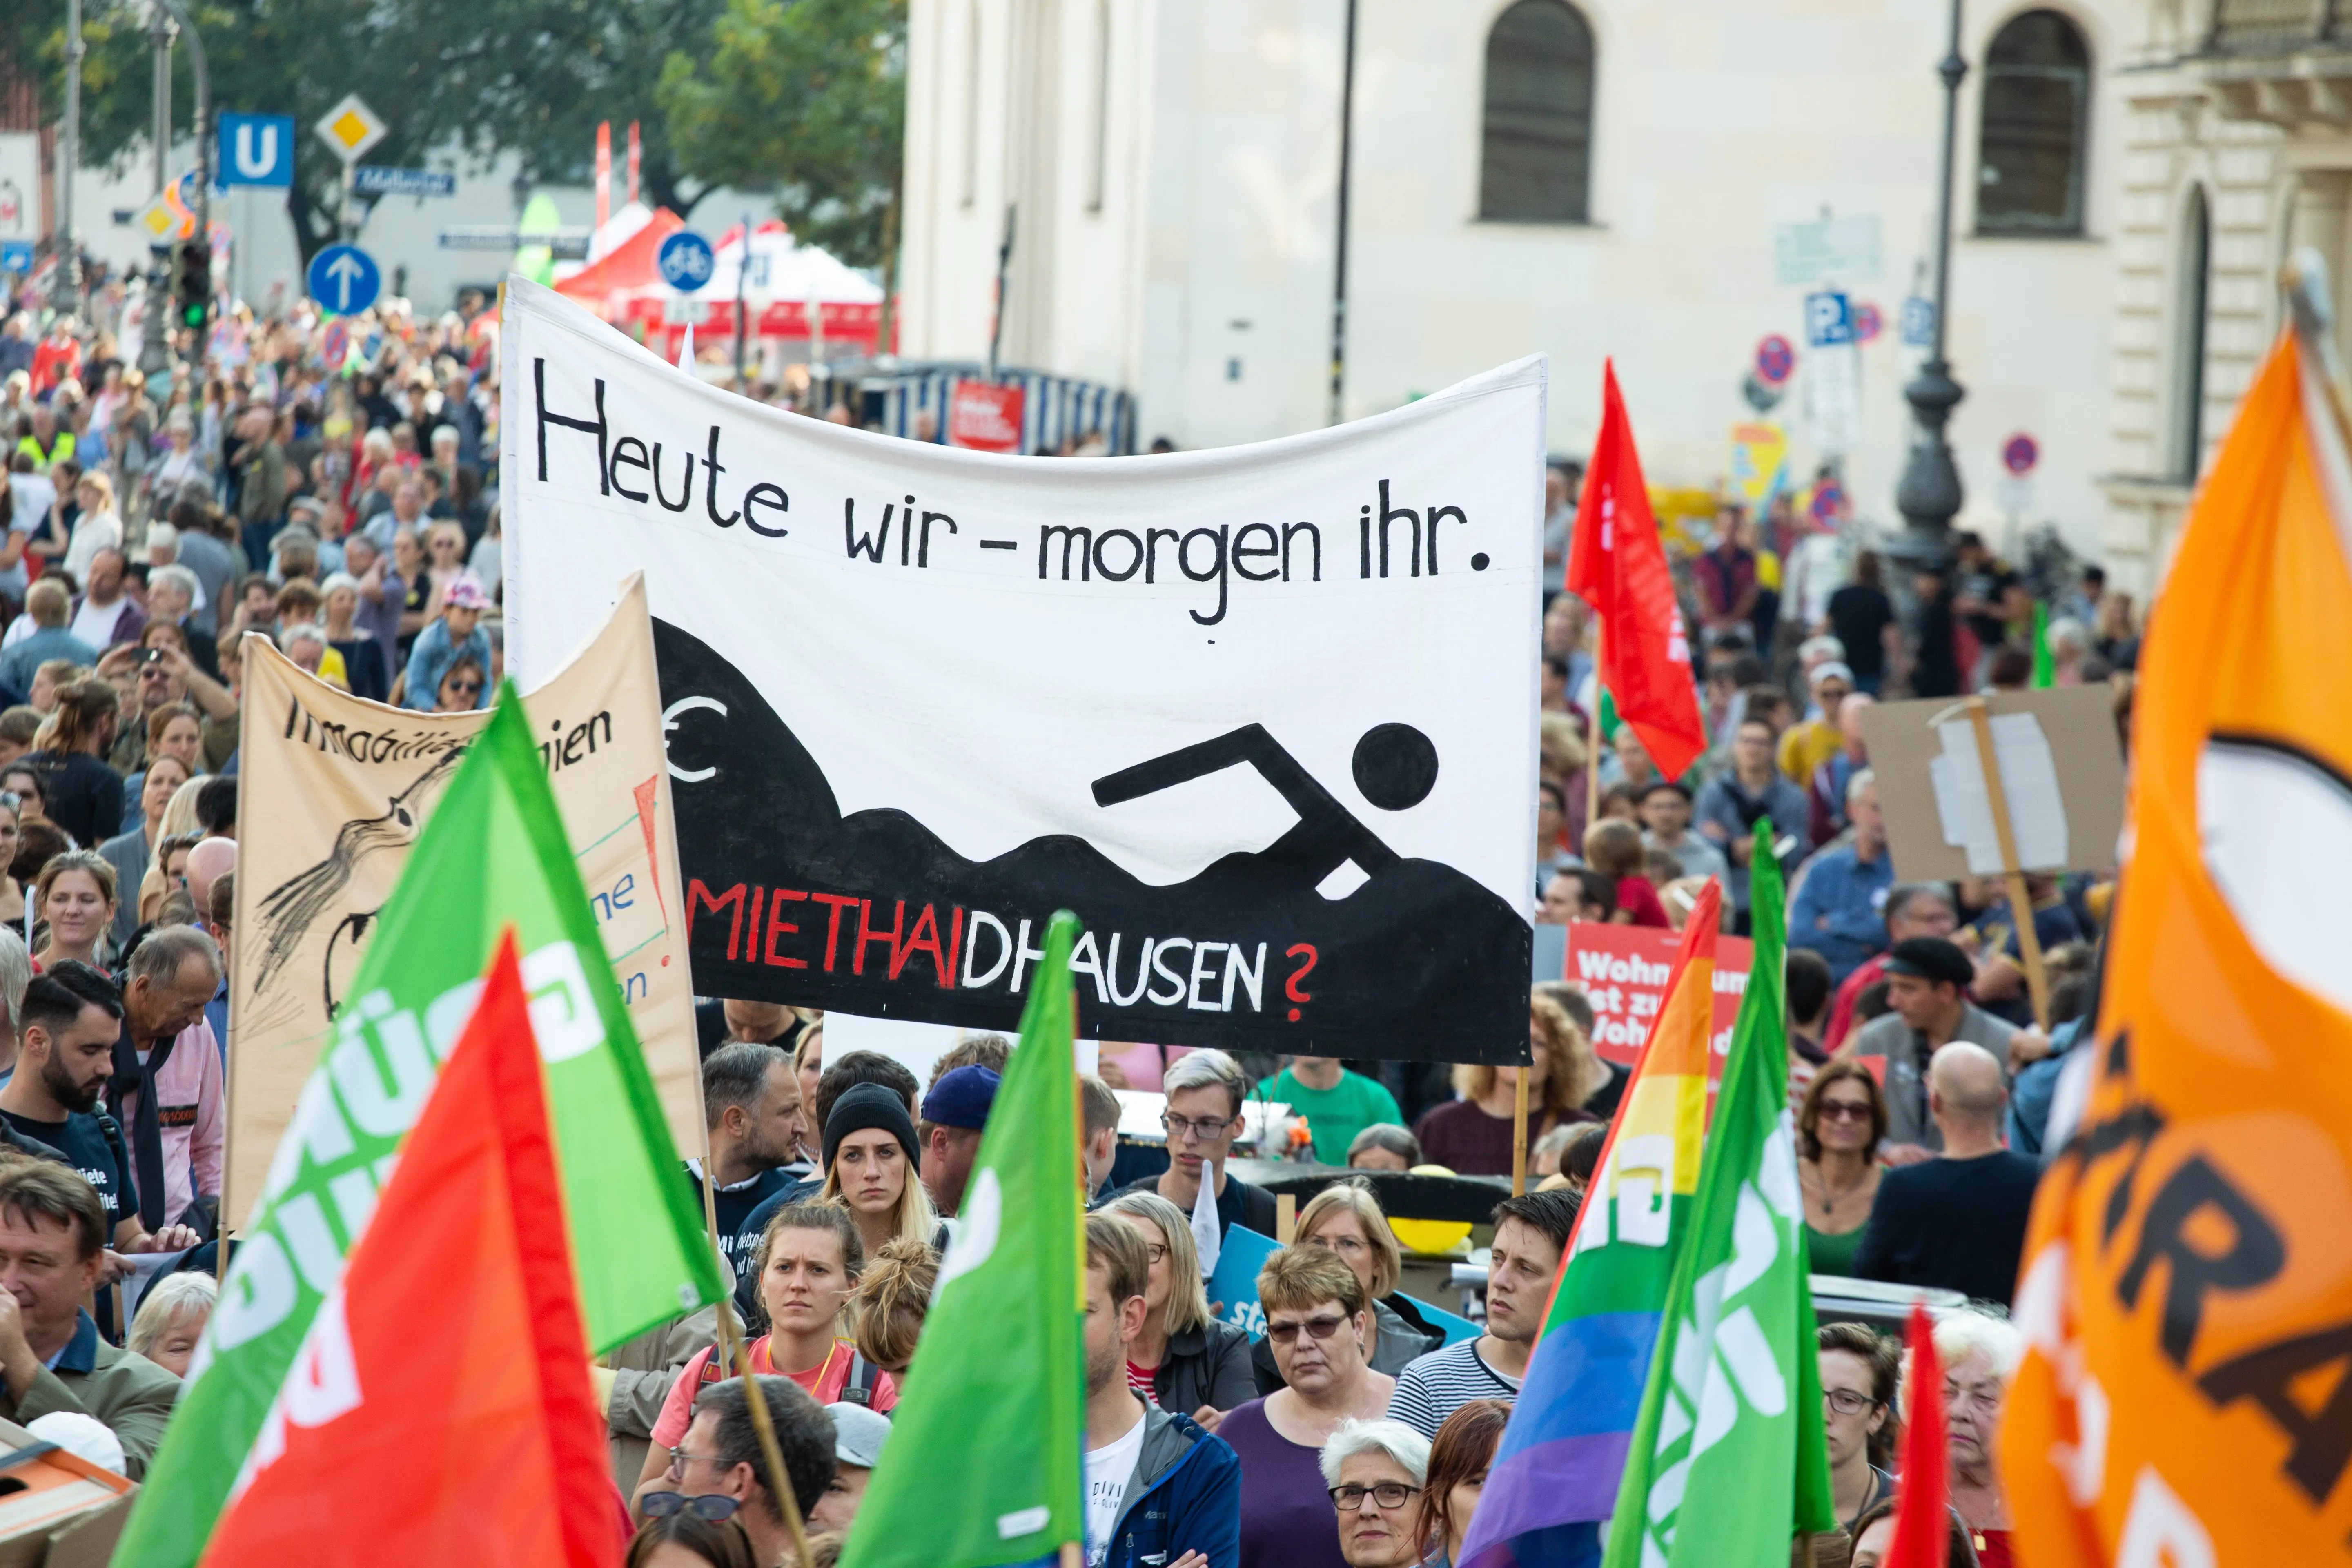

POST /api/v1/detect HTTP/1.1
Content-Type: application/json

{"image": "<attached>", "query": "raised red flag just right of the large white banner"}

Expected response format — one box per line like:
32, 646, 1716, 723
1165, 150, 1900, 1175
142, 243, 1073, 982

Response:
1566, 362, 1708, 778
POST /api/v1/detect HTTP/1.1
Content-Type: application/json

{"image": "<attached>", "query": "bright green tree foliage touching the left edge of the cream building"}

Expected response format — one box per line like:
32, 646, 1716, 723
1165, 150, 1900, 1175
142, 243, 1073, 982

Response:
659, 0, 906, 266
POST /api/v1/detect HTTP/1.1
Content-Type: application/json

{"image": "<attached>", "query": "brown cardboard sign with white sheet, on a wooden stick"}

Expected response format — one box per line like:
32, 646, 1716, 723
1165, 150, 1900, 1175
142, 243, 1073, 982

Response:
1863, 686, 2124, 882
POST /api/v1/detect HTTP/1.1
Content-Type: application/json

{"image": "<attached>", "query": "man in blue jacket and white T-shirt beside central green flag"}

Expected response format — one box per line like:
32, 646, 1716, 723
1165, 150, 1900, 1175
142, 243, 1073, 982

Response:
1087, 1213, 1242, 1568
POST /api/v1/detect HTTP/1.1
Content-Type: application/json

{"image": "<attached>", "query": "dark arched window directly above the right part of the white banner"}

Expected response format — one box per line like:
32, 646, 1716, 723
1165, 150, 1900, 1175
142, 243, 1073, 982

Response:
1477, 0, 1592, 223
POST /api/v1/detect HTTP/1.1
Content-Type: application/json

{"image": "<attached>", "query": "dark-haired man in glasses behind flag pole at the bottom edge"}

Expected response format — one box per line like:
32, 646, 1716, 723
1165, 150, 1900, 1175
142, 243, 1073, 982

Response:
635, 1378, 835, 1563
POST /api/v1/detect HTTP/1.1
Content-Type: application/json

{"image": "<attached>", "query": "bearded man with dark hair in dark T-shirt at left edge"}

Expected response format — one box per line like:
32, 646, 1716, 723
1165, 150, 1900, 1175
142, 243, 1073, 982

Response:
0, 959, 198, 1253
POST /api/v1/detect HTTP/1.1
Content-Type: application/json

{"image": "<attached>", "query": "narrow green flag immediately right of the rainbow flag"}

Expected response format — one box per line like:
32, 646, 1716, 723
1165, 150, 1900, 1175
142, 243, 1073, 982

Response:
1604, 823, 1837, 1568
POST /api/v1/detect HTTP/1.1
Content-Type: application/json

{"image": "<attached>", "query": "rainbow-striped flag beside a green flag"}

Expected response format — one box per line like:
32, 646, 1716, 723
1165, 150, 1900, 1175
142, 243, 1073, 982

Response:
1458, 882, 1722, 1568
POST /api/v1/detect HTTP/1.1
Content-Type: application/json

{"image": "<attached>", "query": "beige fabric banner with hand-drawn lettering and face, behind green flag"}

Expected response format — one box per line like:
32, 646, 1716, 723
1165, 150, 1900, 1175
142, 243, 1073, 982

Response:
223, 576, 703, 1215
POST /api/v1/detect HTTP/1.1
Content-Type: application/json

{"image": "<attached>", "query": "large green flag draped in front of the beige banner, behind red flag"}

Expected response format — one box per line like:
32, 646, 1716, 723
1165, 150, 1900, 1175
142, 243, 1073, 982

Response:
113, 686, 722, 1568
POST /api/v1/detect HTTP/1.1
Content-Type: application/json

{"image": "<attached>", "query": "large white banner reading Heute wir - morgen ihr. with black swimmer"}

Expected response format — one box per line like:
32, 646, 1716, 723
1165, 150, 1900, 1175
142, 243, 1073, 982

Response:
501, 280, 1545, 1060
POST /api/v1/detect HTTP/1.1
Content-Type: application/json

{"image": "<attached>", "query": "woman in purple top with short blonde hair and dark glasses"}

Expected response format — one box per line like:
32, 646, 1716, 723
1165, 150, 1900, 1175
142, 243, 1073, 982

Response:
1216, 1246, 1392, 1568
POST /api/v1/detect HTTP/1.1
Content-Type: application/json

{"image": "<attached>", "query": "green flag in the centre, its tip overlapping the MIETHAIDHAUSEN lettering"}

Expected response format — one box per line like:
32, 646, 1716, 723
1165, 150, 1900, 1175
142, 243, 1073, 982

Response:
842, 910, 1087, 1568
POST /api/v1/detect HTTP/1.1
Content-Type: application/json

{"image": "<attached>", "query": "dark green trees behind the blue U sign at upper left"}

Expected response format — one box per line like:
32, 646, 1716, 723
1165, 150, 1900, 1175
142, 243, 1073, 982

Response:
0, 0, 722, 263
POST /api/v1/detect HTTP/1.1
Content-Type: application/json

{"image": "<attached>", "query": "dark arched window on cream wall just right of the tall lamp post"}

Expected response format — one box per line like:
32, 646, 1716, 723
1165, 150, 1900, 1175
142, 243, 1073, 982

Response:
1976, 12, 2091, 235
